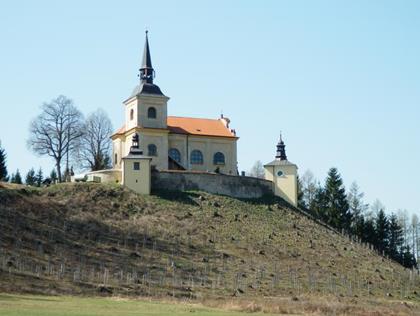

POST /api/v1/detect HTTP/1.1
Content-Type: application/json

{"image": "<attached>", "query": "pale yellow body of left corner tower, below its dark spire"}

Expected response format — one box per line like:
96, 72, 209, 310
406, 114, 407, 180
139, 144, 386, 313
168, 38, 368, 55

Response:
122, 157, 151, 194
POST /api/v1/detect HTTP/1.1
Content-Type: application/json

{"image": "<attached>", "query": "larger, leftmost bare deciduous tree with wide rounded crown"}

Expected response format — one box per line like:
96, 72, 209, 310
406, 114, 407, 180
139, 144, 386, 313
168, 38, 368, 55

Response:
28, 95, 83, 182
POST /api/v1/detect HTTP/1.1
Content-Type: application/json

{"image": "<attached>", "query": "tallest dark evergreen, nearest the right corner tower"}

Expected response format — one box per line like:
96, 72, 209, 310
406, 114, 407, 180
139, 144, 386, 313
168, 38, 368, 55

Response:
325, 168, 351, 231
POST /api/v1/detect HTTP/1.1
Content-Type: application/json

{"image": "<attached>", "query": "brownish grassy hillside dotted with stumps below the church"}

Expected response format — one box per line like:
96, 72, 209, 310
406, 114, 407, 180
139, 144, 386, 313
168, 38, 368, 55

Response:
0, 184, 420, 308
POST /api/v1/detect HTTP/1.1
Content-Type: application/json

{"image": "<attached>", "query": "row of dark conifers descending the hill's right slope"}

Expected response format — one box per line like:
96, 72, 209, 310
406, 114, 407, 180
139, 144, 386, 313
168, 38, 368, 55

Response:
299, 168, 417, 268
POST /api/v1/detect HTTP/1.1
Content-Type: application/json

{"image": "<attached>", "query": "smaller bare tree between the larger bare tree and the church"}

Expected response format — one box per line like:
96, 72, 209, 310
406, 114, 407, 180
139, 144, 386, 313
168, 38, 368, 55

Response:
79, 109, 112, 171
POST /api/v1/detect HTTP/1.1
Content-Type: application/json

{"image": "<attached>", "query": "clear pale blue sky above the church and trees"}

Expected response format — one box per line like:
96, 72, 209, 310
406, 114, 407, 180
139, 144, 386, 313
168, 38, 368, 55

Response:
0, 0, 420, 214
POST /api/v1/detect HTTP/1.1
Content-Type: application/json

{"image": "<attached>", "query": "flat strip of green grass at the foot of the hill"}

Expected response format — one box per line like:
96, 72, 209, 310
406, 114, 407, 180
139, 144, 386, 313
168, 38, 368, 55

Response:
0, 294, 278, 316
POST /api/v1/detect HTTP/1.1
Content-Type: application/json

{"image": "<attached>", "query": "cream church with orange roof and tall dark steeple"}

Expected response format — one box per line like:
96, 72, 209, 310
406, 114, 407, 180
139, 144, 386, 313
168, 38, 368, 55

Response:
111, 31, 238, 175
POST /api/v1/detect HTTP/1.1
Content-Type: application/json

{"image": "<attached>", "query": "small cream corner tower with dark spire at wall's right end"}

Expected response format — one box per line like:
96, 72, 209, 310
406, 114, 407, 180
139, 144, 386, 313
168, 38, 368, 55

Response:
264, 135, 298, 206
